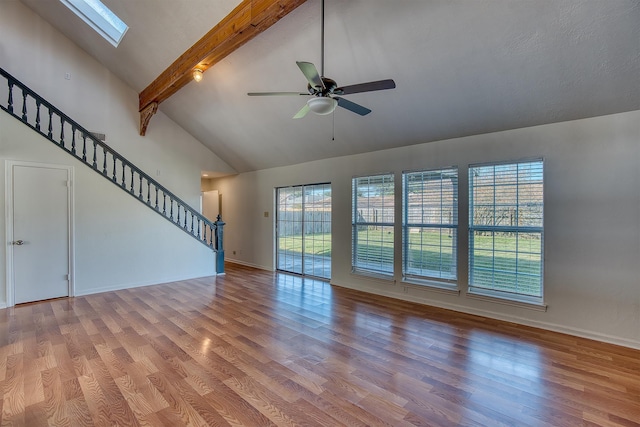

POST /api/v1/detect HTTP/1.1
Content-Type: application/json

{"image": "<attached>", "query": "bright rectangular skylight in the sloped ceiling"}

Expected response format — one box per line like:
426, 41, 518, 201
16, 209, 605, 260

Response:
60, 0, 129, 47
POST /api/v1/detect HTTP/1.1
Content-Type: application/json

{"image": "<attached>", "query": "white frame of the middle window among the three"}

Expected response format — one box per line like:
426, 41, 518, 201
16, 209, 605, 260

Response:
402, 166, 460, 290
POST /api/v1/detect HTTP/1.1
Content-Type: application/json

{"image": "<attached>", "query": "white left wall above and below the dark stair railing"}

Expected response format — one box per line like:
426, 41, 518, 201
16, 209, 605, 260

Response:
0, 1, 234, 307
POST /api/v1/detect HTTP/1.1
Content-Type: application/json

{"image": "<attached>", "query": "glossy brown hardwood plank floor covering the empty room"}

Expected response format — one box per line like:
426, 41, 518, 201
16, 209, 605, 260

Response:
0, 264, 640, 427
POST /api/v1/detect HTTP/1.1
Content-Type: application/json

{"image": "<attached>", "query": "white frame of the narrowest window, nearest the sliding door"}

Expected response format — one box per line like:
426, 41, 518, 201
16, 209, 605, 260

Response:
351, 172, 396, 280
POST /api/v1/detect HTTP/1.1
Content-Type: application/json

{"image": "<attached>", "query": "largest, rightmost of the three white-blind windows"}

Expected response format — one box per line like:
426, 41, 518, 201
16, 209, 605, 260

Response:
469, 160, 544, 304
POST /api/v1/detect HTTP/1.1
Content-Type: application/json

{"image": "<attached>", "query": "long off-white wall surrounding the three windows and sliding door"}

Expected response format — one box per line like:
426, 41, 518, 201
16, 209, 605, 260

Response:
212, 111, 640, 348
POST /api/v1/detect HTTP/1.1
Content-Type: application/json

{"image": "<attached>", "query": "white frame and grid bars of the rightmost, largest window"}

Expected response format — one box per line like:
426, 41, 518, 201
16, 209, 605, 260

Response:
467, 157, 546, 307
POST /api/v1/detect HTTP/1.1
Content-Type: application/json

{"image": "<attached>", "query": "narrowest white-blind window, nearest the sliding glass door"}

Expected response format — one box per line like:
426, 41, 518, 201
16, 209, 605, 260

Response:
351, 174, 394, 276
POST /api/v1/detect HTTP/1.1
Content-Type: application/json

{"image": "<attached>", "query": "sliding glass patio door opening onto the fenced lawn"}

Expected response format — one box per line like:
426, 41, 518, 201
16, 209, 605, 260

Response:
276, 184, 331, 279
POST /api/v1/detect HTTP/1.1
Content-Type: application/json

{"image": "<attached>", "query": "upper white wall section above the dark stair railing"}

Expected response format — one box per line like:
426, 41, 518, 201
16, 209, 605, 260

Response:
0, 1, 234, 197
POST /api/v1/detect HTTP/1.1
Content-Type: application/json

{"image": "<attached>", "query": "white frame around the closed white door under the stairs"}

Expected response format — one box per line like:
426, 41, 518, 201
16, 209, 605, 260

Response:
5, 160, 75, 307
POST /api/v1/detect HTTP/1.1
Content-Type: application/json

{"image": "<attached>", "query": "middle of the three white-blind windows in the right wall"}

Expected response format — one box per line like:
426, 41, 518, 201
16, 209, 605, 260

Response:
402, 168, 458, 283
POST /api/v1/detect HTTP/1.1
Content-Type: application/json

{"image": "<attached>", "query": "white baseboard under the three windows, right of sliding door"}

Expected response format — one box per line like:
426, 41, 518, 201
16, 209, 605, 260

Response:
331, 281, 640, 350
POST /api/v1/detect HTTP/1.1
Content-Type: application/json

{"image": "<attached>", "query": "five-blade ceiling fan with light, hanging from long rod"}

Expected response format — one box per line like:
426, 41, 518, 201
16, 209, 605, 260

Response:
247, 0, 396, 119
